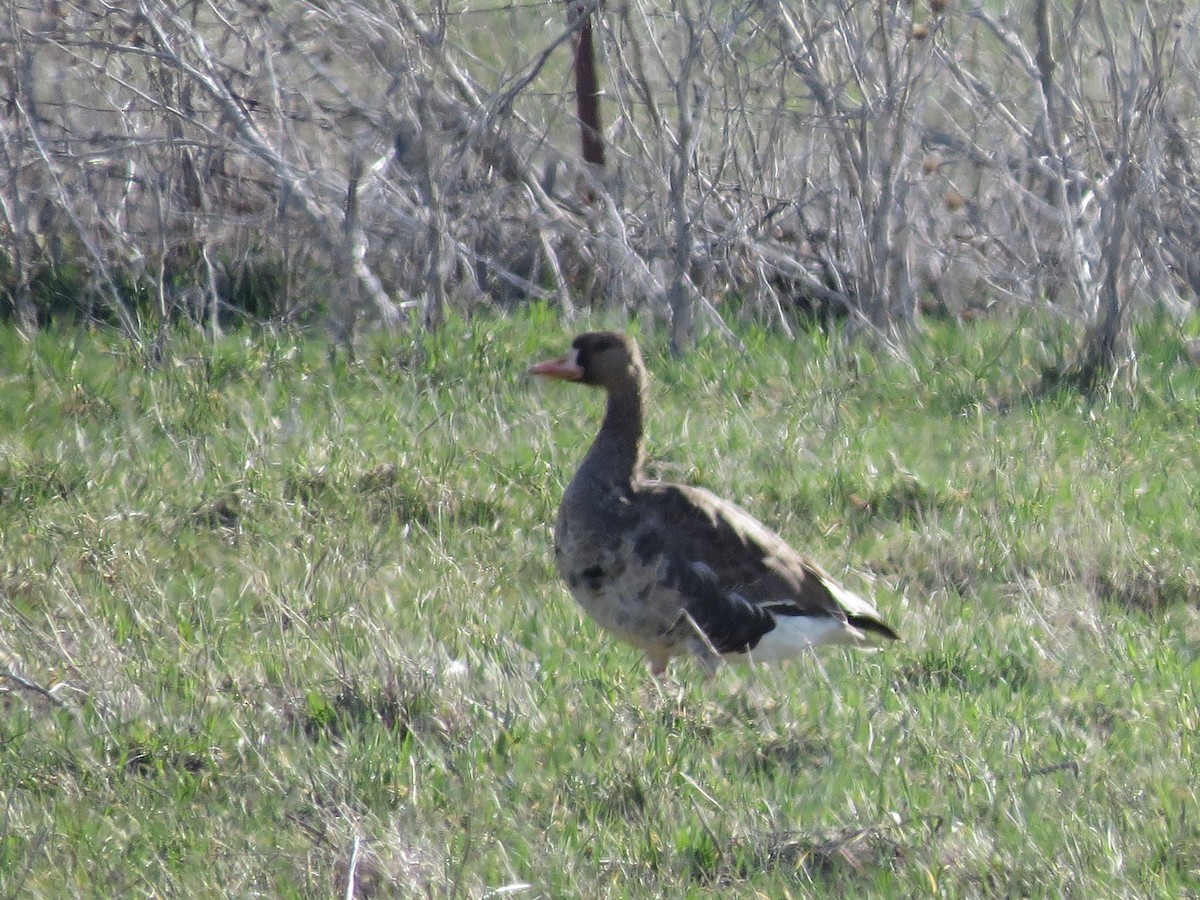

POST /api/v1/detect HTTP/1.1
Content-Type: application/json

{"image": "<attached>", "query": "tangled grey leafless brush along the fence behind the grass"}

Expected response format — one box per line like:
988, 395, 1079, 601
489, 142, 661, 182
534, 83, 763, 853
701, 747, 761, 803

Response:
0, 0, 1200, 360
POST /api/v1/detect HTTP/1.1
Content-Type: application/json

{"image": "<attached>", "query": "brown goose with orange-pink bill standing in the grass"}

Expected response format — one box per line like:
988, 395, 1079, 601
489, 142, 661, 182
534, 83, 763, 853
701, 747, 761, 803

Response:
529, 331, 898, 676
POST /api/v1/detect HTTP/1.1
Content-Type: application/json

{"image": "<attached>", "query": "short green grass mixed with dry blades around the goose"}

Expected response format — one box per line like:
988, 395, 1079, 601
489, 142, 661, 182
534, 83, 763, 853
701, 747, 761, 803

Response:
0, 311, 1200, 898
